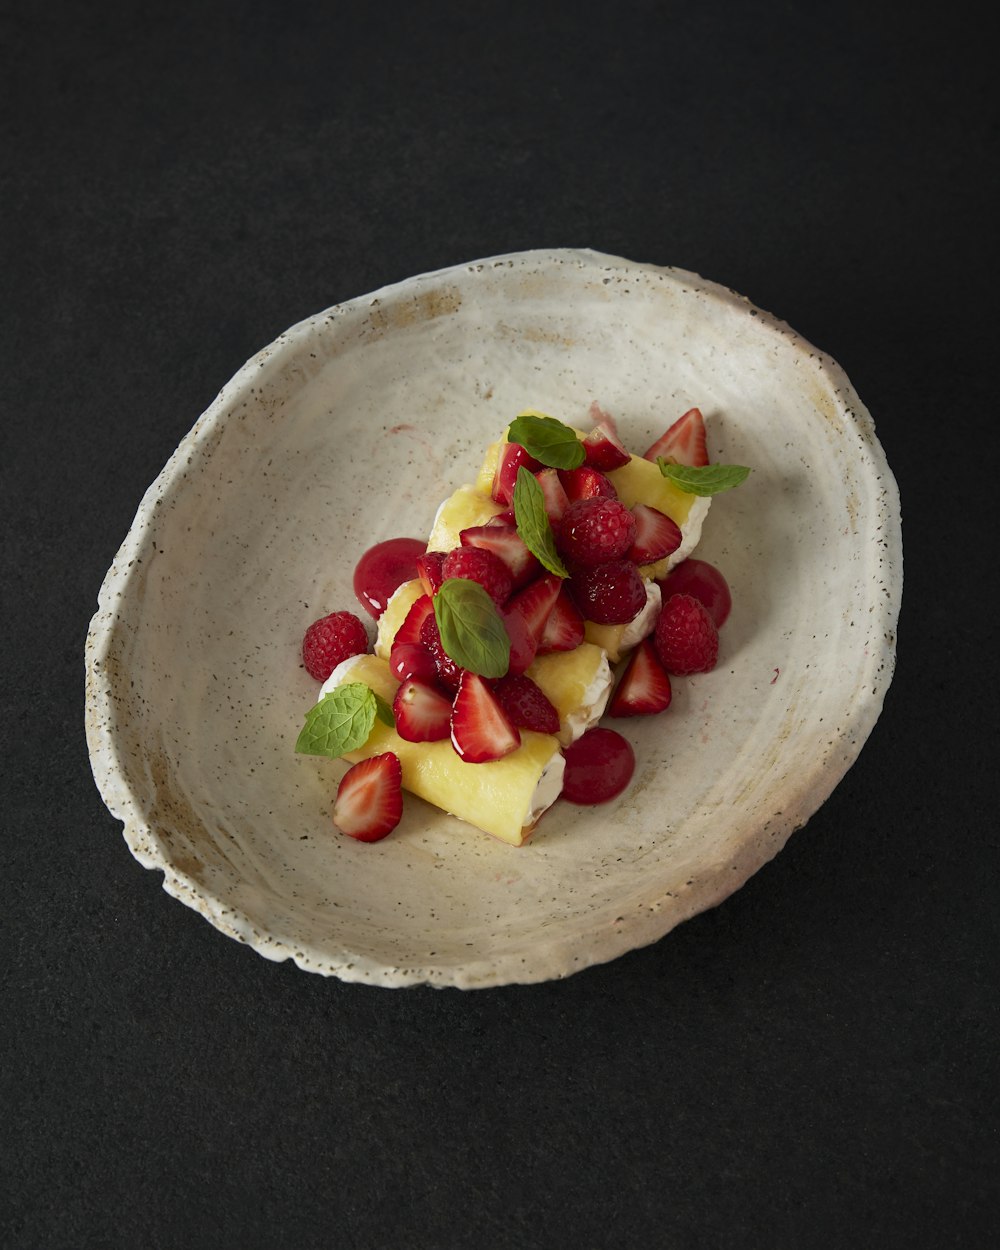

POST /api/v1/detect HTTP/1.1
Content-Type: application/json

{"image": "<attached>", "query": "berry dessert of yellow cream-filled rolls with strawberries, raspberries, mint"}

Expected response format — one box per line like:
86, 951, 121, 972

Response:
296, 405, 749, 844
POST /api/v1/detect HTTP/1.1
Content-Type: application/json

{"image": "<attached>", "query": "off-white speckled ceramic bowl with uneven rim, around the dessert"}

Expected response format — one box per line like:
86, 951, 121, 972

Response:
86, 250, 903, 988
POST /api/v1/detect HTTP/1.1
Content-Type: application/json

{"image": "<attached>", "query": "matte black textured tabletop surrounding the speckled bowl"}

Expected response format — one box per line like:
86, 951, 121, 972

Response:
0, 0, 1000, 1248
